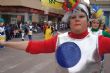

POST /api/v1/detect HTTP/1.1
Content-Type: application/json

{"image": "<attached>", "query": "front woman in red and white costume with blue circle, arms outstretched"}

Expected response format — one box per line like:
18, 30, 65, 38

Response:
0, 3, 110, 73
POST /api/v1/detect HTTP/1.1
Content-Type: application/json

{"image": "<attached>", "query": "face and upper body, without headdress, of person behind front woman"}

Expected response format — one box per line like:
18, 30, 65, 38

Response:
89, 18, 110, 37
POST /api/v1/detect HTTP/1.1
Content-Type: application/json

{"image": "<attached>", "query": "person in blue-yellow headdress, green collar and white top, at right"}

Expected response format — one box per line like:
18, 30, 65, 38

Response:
89, 5, 110, 37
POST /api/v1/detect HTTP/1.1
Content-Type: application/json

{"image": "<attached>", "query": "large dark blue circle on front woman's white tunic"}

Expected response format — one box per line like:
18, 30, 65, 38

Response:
56, 42, 81, 68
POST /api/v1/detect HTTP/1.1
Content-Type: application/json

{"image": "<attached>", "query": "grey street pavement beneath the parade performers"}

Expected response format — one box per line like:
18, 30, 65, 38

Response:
0, 33, 110, 73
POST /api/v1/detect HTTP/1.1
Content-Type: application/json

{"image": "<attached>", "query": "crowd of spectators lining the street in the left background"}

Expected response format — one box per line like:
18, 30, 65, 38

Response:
0, 18, 68, 41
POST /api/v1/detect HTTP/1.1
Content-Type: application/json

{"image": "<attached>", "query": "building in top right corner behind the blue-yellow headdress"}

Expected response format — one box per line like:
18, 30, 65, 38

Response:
90, 0, 110, 27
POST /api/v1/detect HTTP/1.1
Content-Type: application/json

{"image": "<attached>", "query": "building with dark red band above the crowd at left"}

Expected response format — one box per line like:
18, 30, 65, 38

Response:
0, 0, 64, 24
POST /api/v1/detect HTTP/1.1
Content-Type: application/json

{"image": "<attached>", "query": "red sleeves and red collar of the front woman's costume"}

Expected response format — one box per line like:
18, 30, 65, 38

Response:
26, 31, 110, 56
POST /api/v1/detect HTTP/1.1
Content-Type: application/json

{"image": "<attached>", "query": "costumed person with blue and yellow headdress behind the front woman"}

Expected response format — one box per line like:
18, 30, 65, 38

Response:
89, 5, 110, 73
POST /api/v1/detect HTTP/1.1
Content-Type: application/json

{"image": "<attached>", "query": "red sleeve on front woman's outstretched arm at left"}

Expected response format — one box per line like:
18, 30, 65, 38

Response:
26, 36, 57, 54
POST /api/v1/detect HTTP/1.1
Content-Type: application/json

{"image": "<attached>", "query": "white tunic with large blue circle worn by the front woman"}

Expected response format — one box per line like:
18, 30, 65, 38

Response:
56, 33, 100, 73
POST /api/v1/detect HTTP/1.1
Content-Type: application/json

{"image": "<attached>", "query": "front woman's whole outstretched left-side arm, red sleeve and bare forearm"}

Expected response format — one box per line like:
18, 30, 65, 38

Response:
0, 35, 57, 54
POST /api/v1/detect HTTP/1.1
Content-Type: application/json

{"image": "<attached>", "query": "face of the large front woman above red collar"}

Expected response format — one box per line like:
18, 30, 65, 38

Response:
70, 11, 88, 34
